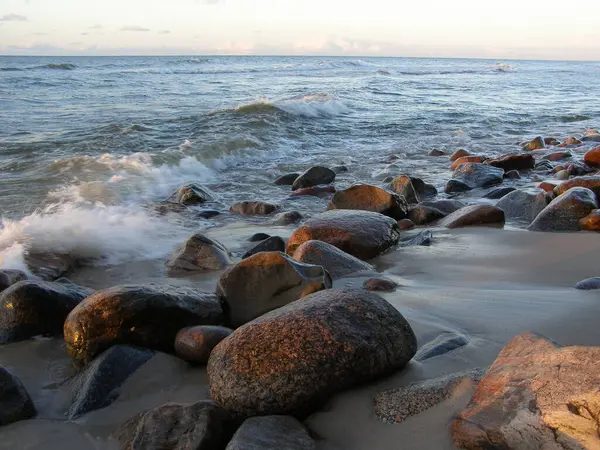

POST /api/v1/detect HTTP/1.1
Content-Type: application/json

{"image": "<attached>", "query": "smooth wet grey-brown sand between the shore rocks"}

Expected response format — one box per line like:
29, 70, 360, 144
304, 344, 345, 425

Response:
0, 224, 600, 450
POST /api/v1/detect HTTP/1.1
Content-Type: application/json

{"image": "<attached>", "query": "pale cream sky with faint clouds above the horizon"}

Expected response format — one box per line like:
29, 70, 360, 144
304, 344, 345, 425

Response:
0, 0, 600, 61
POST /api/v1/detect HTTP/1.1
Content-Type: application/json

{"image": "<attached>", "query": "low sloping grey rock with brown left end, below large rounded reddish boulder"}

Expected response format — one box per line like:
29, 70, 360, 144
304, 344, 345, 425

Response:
293, 241, 373, 280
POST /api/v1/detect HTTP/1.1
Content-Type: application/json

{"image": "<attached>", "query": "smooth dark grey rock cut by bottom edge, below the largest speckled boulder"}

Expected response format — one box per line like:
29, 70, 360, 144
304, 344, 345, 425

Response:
225, 416, 316, 450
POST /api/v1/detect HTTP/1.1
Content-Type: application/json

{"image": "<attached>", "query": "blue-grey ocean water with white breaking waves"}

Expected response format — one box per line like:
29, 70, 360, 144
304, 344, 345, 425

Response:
0, 56, 600, 274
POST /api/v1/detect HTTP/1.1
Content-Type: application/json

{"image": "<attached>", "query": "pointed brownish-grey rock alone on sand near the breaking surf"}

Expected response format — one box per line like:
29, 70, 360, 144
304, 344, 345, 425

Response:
166, 234, 233, 272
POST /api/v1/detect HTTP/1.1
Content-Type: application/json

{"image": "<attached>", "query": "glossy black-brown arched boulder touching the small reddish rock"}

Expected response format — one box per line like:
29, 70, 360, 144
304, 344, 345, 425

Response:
64, 283, 223, 366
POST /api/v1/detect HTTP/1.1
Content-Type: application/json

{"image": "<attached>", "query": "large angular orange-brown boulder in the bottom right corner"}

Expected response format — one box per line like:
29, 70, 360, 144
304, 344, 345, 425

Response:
452, 333, 600, 450
